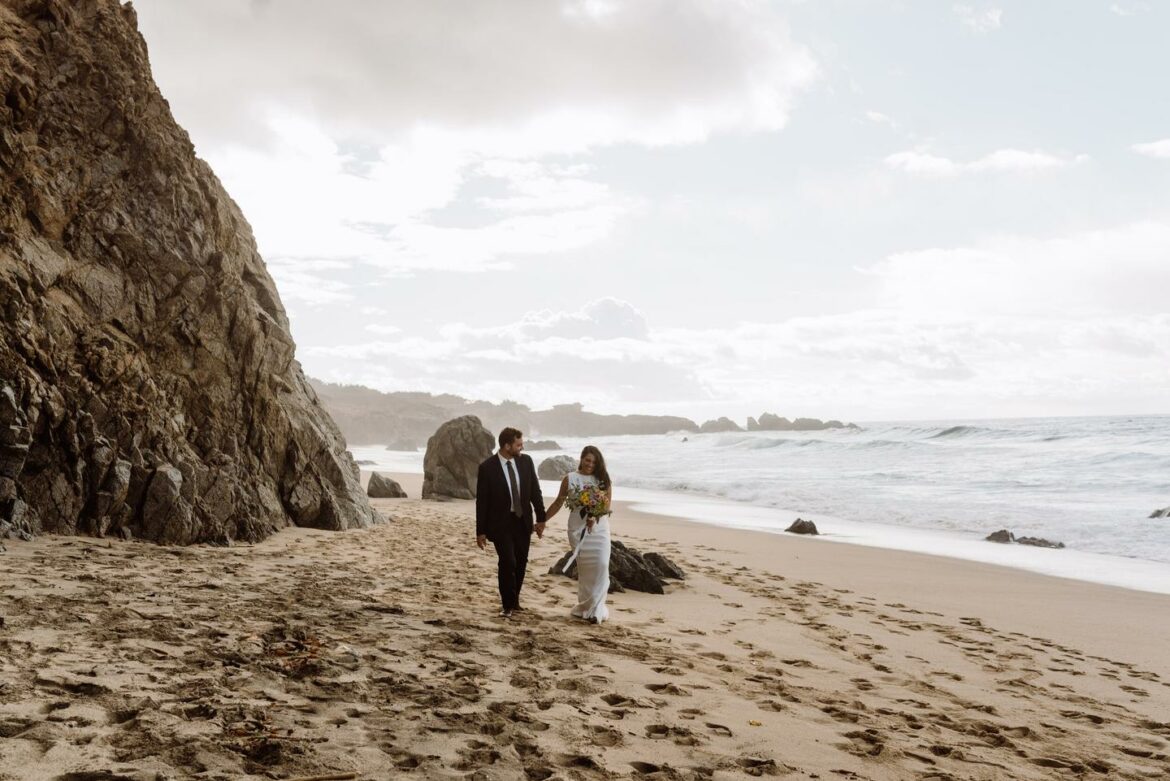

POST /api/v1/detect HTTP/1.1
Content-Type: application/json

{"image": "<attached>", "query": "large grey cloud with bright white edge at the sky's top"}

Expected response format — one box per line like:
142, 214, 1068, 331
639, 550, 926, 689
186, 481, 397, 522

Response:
135, 0, 818, 157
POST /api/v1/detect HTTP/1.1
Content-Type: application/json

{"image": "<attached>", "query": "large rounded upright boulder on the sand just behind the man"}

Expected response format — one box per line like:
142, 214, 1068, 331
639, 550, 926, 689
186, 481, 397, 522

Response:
422, 415, 496, 500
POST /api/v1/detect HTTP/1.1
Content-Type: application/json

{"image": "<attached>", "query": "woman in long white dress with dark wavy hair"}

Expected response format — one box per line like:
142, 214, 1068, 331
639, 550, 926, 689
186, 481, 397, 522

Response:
548, 444, 613, 623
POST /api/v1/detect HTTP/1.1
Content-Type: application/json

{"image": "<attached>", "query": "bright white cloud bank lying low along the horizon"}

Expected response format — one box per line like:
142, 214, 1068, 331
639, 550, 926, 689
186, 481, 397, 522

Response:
304, 221, 1170, 420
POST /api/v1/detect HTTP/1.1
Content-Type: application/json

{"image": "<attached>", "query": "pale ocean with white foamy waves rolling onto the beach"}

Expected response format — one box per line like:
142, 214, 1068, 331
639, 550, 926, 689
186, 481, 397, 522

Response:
355, 415, 1170, 593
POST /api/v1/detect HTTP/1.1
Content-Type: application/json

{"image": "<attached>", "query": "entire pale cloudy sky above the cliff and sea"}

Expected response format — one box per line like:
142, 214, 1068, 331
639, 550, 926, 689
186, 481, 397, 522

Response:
133, 0, 1170, 422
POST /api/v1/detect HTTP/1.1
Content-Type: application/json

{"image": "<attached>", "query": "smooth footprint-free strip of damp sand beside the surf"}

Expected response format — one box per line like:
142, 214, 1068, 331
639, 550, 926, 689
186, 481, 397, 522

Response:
386, 471, 1170, 673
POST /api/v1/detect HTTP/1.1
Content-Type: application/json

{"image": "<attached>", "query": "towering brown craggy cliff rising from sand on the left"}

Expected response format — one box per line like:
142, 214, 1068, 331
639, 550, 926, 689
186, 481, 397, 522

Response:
0, 0, 378, 542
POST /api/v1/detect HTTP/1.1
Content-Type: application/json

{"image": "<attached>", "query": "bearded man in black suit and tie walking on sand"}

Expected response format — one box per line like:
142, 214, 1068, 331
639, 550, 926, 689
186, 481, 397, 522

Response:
475, 428, 545, 618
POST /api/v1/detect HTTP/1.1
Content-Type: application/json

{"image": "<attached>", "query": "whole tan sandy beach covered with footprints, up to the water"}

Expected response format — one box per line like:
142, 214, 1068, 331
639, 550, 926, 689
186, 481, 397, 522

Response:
0, 475, 1170, 781
